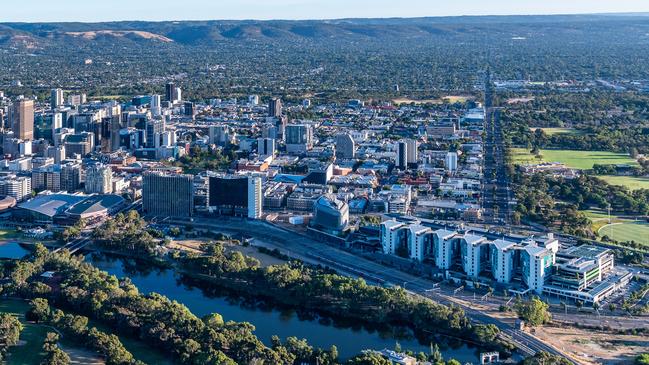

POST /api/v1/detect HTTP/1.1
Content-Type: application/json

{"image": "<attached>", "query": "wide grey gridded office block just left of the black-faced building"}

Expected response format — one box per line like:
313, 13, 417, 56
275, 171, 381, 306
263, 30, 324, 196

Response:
142, 172, 194, 217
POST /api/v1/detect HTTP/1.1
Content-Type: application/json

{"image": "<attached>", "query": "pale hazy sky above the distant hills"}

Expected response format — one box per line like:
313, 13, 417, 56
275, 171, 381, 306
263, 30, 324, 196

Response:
0, 0, 649, 22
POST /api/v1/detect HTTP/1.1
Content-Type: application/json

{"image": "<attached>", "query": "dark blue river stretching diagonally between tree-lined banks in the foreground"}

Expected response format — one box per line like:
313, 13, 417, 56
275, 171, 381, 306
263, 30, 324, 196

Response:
88, 255, 477, 363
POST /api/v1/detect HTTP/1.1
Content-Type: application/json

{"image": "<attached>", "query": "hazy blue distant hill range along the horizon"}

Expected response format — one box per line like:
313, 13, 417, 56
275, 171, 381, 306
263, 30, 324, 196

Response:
0, 13, 649, 48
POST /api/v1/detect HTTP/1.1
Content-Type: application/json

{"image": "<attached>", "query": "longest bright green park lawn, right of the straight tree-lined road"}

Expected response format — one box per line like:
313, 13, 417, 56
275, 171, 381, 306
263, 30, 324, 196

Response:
512, 148, 637, 170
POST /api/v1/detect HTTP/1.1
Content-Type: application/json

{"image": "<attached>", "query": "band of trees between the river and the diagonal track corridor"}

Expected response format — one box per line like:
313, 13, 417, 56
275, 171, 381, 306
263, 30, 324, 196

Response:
176, 240, 498, 346
